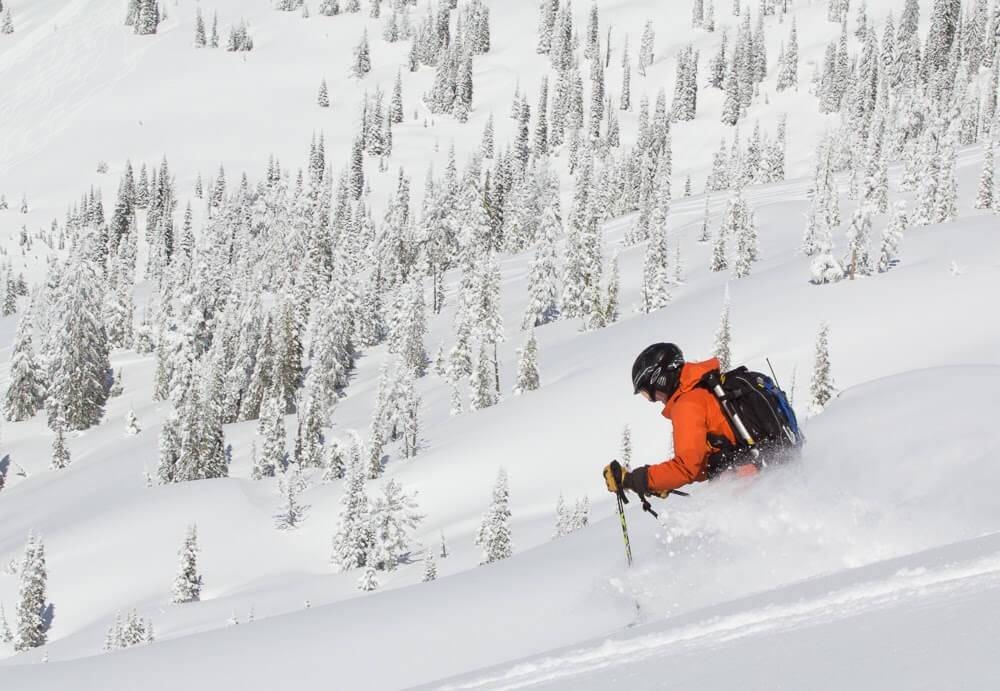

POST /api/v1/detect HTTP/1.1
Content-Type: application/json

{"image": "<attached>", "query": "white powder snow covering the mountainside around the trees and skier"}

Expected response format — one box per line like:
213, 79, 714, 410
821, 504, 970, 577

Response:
0, 0, 1000, 691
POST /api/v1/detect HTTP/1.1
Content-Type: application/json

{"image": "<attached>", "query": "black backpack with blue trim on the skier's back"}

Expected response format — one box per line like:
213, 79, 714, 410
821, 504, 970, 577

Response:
699, 367, 805, 478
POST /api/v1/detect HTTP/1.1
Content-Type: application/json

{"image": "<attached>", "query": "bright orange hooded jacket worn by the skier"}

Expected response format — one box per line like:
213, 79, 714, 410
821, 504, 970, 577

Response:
647, 358, 736, 494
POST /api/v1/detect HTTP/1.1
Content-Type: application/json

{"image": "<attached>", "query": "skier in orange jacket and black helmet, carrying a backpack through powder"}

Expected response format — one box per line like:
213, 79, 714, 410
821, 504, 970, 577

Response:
604, 343, 801, 497
